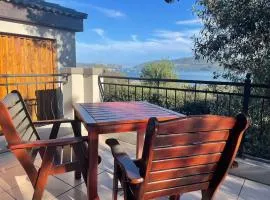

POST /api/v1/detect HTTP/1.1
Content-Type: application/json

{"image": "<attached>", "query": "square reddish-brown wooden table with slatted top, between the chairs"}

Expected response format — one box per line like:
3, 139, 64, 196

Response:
73, 102, 184, 200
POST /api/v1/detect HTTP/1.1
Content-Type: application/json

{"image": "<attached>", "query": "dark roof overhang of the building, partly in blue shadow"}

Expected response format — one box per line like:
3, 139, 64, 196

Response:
0, 0, 87, 32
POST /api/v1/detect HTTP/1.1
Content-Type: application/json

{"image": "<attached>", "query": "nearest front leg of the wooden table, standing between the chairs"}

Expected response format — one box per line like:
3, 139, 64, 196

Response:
87, 127, 99, 200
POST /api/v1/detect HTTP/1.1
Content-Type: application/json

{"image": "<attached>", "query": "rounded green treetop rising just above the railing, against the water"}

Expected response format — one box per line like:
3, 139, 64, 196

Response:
141, 60, 177, 79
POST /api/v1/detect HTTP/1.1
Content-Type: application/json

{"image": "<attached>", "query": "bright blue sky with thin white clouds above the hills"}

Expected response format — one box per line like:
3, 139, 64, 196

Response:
47, 0, 202, 66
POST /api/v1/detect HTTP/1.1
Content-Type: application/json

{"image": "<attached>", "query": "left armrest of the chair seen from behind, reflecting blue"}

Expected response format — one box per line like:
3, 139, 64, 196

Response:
106, 139, 144, 184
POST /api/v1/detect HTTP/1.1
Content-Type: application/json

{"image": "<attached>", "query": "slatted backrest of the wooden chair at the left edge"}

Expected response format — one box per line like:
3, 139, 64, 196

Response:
0, 91, 40, 145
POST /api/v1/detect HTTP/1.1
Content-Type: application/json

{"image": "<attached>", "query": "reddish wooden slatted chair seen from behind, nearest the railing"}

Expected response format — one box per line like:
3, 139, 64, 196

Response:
106, 114, 248, 200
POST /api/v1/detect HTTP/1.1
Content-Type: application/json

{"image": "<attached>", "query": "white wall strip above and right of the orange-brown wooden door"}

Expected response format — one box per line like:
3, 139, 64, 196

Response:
0, 19, 76, 68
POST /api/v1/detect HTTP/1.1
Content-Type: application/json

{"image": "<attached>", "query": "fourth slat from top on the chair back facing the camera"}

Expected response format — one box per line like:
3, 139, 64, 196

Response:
151, 153, 221, 171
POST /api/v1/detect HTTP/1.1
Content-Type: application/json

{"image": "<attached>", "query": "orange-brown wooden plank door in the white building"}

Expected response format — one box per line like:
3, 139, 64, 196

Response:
0, 33, 56, 118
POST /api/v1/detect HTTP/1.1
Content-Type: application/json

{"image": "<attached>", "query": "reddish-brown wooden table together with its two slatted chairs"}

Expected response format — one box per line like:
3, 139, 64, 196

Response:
0, 91, 249, 200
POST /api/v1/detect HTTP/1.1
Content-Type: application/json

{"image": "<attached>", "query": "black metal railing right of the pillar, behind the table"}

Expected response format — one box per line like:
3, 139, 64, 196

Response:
99, 74, 270, 160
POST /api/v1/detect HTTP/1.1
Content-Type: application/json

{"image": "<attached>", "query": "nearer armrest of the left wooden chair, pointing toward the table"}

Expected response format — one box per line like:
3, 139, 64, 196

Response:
8, 136, 88, 150
